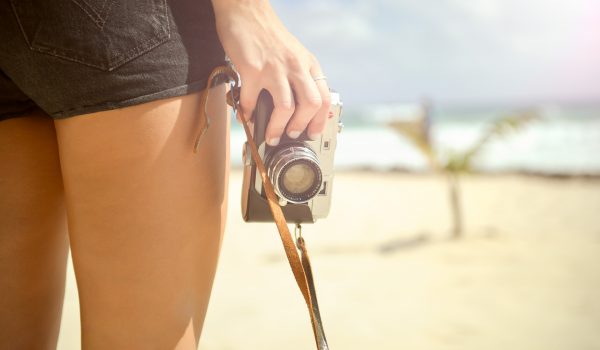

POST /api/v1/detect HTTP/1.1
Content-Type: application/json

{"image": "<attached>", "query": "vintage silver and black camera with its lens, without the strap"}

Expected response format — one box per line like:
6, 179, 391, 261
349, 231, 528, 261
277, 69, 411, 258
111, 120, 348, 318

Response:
242, 90, 343, 224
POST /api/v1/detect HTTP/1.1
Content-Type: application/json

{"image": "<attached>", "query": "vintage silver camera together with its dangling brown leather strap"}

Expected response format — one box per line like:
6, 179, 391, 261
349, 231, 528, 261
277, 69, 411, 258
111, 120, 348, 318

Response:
210, 66, 342, 350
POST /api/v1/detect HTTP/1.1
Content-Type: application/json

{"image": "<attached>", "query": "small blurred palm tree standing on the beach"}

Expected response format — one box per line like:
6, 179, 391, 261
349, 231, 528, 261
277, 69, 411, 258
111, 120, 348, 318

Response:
388, 106, 538, 239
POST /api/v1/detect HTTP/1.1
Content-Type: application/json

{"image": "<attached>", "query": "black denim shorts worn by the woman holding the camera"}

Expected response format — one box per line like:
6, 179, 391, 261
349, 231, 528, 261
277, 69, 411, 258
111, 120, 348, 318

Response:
0, 0, 225, 120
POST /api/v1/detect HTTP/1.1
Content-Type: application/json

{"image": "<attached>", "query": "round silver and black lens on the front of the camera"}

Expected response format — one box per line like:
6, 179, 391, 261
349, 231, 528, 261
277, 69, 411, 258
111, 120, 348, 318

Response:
267, 145, 323, 203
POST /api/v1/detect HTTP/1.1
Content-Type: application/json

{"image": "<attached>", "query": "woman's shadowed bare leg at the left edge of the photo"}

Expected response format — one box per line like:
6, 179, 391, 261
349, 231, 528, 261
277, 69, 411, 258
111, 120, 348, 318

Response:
0, 111, 69, 349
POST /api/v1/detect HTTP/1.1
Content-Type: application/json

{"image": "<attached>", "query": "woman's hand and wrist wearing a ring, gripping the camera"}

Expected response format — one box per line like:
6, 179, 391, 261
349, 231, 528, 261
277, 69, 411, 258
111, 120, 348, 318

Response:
212, 0, 330, 146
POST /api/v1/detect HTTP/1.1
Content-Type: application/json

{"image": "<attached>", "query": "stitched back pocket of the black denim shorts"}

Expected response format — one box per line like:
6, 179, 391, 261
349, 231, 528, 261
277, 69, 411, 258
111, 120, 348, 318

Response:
11, 0, 170, 71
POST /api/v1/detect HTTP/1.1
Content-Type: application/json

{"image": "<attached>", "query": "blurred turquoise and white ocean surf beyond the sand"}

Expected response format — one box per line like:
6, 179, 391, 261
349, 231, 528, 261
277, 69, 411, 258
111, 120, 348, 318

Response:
231, 104, 600, 175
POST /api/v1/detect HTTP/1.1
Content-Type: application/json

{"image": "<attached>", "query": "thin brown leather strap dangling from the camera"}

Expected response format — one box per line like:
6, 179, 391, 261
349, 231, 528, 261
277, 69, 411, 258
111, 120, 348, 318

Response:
194, 66, 329, 350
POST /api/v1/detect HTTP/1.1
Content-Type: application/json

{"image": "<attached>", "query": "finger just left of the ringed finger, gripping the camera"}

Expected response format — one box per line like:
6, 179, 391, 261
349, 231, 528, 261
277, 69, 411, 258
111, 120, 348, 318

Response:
287, 72, 322, 139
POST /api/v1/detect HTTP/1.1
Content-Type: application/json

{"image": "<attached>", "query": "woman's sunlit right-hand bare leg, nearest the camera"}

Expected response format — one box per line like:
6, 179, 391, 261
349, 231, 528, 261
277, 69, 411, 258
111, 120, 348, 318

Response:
55, 85, 229, 350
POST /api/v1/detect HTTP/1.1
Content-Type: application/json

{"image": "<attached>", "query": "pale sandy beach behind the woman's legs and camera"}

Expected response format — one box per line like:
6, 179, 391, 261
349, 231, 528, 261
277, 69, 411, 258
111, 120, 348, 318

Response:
58, 171, 600, 350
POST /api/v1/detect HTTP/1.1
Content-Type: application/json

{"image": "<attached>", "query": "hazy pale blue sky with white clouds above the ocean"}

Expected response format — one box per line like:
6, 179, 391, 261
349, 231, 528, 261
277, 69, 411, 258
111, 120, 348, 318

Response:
271, 0, 600, 105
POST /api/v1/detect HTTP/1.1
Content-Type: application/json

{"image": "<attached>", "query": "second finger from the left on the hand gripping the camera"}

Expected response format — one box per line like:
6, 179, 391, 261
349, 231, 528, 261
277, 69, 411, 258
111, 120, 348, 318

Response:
265, 79, 294, 146
